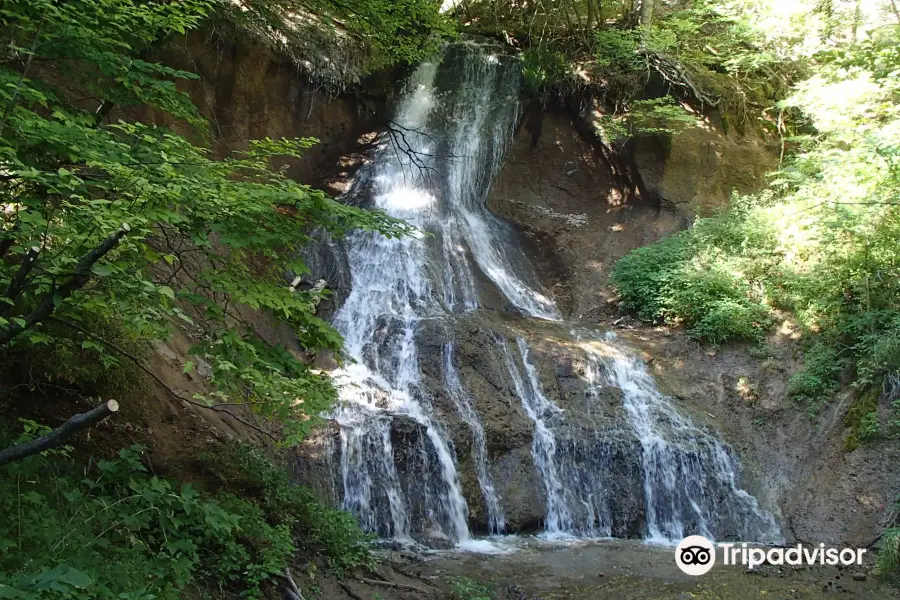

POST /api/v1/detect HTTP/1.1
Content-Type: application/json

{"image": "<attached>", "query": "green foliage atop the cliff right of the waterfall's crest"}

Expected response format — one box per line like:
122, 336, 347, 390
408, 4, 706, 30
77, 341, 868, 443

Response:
456, 0, 799, 132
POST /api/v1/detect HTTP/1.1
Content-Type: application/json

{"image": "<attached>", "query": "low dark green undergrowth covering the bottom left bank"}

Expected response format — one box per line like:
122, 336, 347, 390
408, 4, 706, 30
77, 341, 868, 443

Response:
0, 434, 369, 600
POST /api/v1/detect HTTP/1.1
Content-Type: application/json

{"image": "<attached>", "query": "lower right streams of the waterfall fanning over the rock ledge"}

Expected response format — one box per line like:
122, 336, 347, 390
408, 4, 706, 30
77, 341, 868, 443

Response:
503, 332, 781, 542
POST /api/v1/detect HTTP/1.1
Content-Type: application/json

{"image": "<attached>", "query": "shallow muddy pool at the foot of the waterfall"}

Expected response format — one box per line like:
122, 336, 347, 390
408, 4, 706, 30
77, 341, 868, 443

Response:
385, 538, 900, 600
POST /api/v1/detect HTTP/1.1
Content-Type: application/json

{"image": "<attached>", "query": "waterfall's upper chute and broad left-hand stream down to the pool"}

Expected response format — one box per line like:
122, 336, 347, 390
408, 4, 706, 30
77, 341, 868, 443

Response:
333, 44, 555, 543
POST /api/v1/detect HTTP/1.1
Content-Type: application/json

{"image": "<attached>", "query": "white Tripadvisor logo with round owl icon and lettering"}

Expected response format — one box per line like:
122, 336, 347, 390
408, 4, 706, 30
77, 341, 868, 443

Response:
675, 535, 866, 575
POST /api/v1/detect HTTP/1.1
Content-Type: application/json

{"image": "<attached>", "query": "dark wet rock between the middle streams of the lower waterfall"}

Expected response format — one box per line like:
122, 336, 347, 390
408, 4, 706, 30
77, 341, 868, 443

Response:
417, 321, 646, 537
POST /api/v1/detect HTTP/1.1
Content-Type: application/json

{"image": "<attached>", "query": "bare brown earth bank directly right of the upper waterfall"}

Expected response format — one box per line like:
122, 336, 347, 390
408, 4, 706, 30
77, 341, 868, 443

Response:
488, 113, 683, 316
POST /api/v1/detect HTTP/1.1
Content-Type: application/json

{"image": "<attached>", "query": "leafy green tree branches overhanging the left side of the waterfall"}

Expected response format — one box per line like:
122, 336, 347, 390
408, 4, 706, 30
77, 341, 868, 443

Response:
0, 0, 407, 441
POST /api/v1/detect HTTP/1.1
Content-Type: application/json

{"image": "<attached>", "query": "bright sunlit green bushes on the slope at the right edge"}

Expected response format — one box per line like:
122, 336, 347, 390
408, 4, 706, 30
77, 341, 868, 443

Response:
612, 12, 900, 432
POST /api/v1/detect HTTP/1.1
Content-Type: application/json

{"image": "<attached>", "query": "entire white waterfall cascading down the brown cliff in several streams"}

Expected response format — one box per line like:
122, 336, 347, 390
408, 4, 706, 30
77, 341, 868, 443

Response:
331, 43, 778, 544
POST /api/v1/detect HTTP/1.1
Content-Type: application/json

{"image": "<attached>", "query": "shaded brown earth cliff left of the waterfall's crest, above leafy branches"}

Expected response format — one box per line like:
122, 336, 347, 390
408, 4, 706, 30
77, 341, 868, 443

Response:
147, 30, 402, 195
